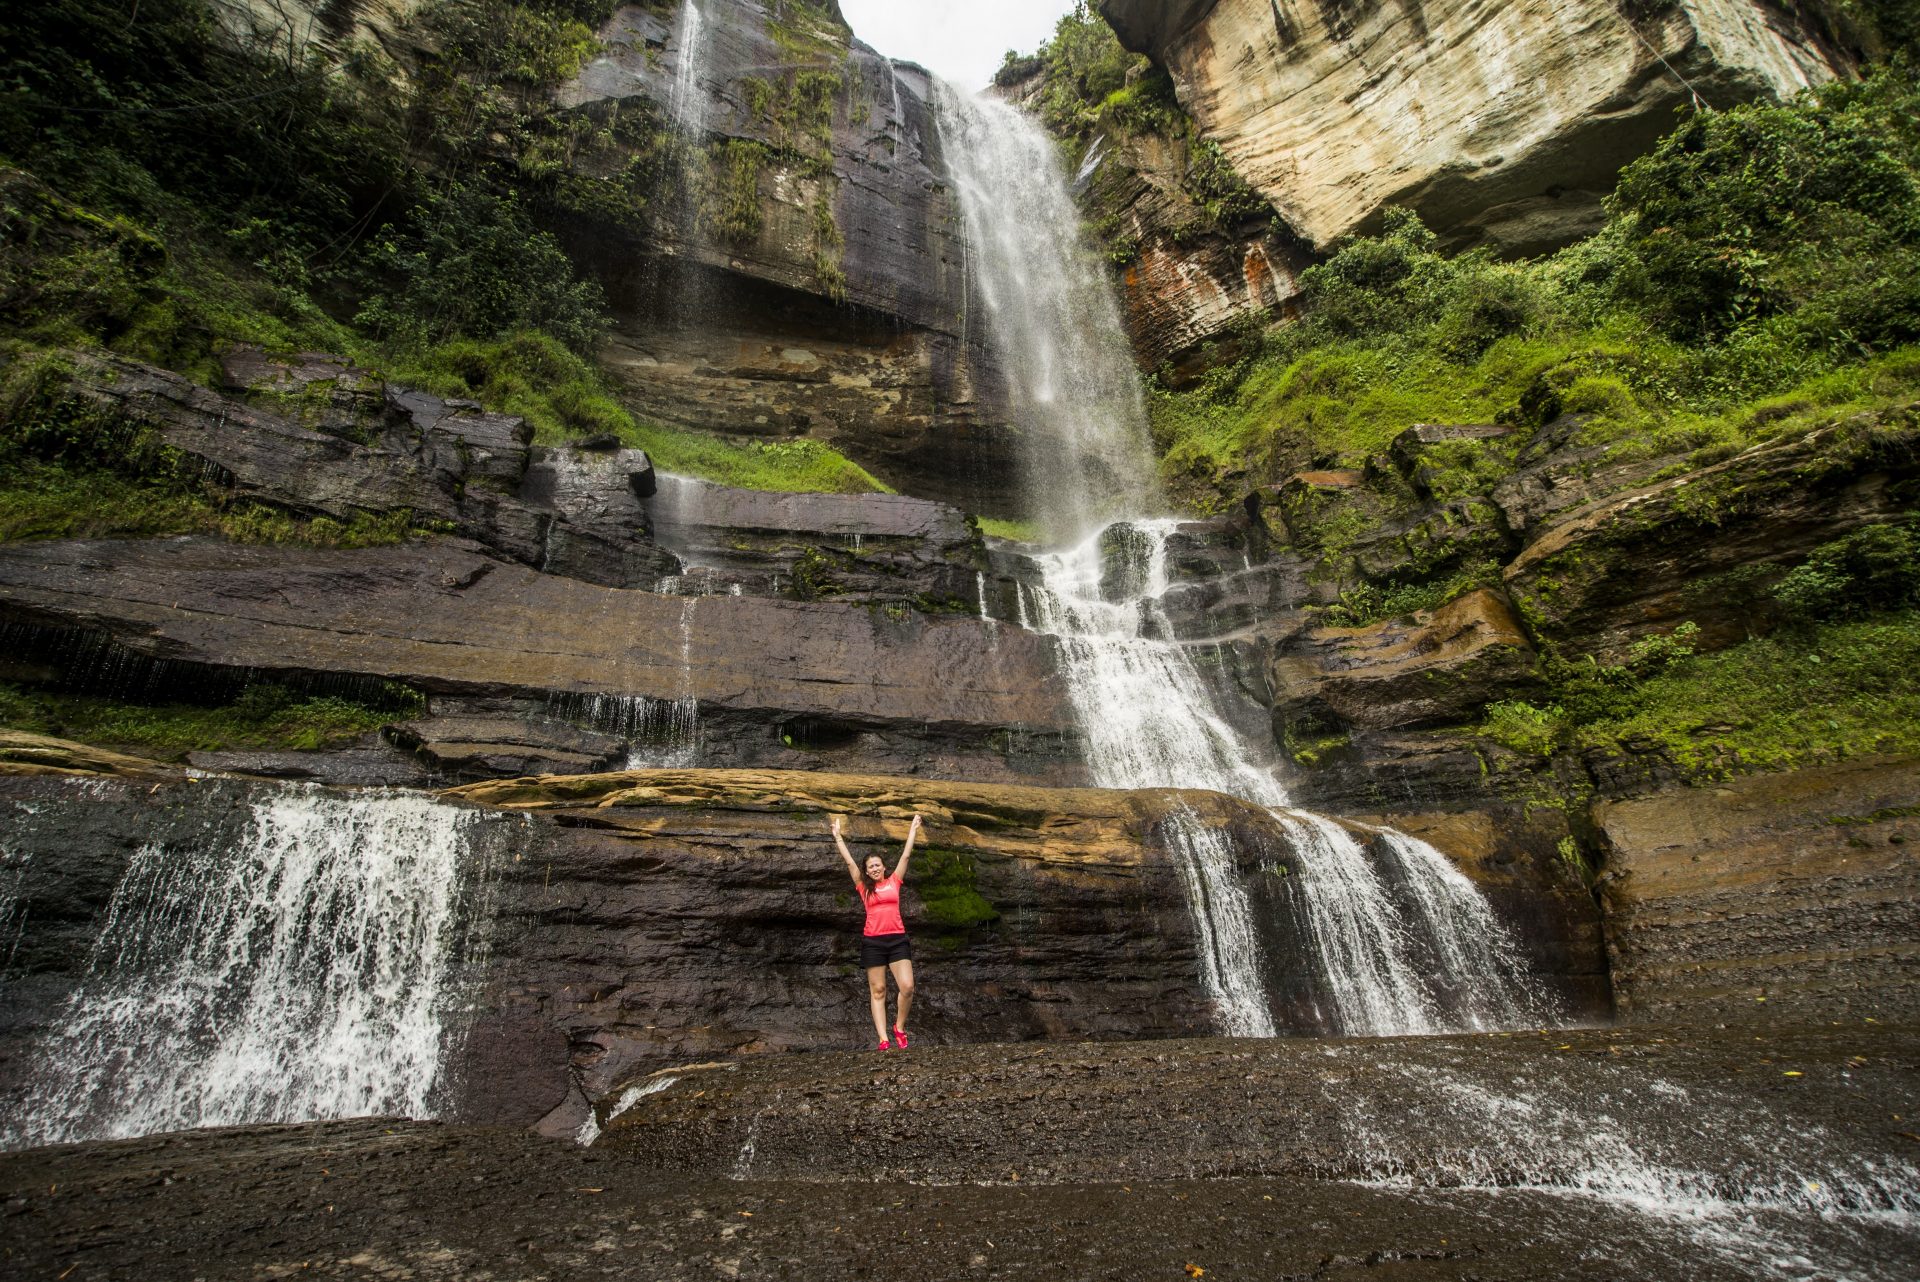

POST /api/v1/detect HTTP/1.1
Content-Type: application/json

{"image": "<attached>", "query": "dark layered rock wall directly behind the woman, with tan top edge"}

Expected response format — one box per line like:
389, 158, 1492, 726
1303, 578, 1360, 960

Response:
0, 737, 1605, 1134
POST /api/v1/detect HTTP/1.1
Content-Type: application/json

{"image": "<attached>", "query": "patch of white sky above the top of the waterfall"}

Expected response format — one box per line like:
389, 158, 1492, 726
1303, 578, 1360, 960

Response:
841, 0, 1073, 88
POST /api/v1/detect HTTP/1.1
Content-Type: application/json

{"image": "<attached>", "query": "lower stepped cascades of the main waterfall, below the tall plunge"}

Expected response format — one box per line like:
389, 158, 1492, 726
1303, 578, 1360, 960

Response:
1020, 520, 1553, 1036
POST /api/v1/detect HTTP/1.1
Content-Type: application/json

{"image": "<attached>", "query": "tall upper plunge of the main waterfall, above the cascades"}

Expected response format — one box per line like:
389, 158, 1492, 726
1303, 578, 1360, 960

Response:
935, 83, 1156, 537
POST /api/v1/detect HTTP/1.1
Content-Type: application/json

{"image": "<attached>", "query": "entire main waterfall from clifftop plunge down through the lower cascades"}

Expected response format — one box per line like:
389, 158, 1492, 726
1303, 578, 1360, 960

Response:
937, 84, 1551, 1036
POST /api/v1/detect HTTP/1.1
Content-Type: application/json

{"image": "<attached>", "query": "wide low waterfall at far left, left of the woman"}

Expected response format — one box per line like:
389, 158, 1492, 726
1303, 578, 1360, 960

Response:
6, 789, 478, 1146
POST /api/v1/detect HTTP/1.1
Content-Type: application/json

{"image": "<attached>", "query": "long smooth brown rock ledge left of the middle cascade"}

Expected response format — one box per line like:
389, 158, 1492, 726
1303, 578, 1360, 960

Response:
0, 539, 1079, 783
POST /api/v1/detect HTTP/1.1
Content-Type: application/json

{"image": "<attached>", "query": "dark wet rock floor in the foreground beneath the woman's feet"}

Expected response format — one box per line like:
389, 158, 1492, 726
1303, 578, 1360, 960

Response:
0, 1029, 1916, 1282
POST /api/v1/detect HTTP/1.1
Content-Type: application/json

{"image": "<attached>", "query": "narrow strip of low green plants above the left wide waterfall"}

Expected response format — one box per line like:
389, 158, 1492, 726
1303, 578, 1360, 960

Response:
0, 683, 424, 758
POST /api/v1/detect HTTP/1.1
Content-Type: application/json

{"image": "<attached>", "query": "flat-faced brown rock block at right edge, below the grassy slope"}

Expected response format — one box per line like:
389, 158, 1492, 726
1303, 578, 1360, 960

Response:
1594, 758, 1920, 1023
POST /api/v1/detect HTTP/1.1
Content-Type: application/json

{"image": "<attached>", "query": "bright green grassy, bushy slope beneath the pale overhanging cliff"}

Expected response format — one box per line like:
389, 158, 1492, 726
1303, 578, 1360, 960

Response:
1152, 69, 1920, 509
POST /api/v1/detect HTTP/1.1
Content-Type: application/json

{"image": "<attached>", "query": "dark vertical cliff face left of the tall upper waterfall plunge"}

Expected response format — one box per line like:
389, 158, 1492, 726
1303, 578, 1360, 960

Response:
557, 0, 1012, 512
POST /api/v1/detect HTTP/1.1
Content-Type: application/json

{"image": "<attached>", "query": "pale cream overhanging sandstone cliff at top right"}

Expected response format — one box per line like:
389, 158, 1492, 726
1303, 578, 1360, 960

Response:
1102, 0, 1845, 255
